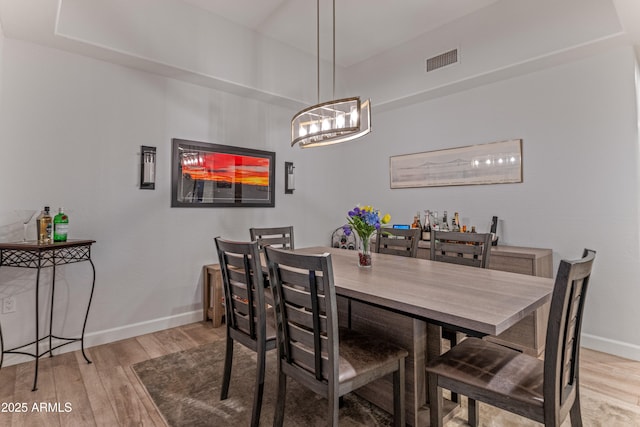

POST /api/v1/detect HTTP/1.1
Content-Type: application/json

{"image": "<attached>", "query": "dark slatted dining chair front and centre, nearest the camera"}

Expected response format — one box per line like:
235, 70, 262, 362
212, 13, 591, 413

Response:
265, 246, 408, 427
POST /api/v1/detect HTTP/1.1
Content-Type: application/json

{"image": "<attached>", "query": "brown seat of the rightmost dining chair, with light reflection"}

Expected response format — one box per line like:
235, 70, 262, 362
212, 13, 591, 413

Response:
426, 338, 544, 407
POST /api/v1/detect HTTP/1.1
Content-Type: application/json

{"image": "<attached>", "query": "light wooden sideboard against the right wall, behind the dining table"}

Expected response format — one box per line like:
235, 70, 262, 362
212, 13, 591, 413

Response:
418, 240, 553, 356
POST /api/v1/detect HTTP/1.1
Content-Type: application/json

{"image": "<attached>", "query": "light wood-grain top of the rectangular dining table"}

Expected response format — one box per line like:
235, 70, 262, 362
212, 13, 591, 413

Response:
295, 246, 554, 335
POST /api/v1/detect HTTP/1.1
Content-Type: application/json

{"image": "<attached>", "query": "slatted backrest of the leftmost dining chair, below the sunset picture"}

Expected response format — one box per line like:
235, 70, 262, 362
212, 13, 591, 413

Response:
215, 237, 266, 348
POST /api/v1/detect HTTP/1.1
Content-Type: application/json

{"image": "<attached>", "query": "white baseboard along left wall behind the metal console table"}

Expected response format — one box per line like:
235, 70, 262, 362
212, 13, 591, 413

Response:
2, 310, 202, 366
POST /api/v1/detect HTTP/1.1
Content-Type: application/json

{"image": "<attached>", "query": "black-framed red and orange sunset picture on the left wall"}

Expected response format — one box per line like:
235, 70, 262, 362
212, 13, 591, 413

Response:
171, 139, 276, 207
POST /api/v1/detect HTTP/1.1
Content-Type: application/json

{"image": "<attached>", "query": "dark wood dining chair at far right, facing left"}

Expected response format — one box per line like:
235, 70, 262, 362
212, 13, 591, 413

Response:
427, 249, 595, 426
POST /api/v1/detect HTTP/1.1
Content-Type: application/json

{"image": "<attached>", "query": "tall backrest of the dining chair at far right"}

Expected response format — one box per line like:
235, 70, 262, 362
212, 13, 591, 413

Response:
543, 249, 596, 420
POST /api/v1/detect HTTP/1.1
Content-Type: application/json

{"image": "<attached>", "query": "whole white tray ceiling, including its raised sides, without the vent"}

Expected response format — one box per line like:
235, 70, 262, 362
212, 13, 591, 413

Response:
0, 0, 640, 109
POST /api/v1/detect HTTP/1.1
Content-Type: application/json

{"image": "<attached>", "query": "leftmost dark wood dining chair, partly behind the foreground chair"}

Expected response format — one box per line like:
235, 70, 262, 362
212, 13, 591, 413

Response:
215, 237, 276, 426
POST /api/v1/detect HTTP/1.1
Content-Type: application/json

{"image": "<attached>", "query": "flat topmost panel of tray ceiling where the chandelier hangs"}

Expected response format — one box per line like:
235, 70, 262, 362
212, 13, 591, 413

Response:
174, 0, 498, 67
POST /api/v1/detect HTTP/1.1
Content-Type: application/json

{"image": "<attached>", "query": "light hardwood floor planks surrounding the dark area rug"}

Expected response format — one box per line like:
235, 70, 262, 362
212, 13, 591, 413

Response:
0, 322, 640, 427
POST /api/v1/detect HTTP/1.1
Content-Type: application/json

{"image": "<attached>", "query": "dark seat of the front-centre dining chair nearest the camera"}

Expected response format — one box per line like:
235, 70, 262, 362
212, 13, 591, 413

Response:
338, 328, 408, 383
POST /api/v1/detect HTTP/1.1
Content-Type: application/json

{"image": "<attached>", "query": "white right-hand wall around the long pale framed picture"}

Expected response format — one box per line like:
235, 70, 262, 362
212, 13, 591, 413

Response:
342, 47, 640, 360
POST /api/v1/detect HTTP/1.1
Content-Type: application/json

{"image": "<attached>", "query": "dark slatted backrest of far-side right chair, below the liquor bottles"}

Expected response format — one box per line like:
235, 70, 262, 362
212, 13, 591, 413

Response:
430, 230, 491, 268
